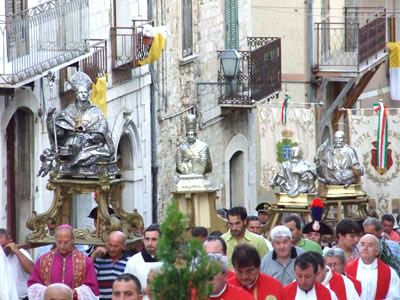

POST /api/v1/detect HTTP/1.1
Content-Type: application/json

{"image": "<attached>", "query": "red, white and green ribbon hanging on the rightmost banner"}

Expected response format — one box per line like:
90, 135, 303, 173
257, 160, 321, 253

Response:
373, 102, 388, 169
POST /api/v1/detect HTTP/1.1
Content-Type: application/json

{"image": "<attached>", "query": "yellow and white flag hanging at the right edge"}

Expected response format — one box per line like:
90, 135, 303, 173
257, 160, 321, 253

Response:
387, 42, 400, 100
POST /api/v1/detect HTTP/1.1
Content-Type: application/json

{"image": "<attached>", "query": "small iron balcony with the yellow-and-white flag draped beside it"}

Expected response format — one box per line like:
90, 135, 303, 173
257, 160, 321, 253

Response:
110, 20, 152, 69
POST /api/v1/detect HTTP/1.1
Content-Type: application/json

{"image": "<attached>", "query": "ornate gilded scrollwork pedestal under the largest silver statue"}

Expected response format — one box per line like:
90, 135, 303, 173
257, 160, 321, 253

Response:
26, 175, 143, 245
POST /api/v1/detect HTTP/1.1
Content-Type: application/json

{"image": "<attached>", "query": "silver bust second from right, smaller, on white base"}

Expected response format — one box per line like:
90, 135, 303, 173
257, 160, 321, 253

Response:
271, 146, 317, 198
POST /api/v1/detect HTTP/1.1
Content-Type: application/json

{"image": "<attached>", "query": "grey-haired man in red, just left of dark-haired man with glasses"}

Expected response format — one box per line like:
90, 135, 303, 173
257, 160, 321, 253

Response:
208, 253, 254, 300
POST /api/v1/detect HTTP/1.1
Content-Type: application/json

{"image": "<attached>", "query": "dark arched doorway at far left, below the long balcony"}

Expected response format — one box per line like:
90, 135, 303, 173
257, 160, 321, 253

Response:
6, 108, 34, 243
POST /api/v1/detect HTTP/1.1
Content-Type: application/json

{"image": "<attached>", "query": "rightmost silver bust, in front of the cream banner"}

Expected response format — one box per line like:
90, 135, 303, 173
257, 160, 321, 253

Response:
314, 131, 364, 188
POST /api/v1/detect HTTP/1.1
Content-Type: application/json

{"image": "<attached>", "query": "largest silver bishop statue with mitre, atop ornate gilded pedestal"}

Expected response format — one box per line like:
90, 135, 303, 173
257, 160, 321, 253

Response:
39, 72, 115, 176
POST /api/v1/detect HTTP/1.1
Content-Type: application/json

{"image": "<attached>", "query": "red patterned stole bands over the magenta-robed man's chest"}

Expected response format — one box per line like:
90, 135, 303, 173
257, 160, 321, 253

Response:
40, 248, 86, 289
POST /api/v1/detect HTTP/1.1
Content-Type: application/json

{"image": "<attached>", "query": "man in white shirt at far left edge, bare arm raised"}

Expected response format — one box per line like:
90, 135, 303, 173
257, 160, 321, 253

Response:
0, 228, 35, 299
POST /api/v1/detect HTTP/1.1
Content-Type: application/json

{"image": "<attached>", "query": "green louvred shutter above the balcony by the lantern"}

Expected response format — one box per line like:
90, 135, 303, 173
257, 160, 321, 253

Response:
225, 0, 239, 49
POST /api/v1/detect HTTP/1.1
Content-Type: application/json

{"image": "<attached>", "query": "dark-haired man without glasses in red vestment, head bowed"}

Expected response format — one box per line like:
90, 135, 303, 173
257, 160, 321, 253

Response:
285, 252, 337, 300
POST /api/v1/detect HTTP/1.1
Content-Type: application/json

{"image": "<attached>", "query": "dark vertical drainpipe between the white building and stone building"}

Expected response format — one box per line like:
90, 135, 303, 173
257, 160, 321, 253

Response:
147, 0, 158, 223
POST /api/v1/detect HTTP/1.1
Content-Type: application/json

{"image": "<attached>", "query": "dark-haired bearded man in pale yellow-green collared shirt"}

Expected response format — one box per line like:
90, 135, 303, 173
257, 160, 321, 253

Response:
221, 206, 269, 269
